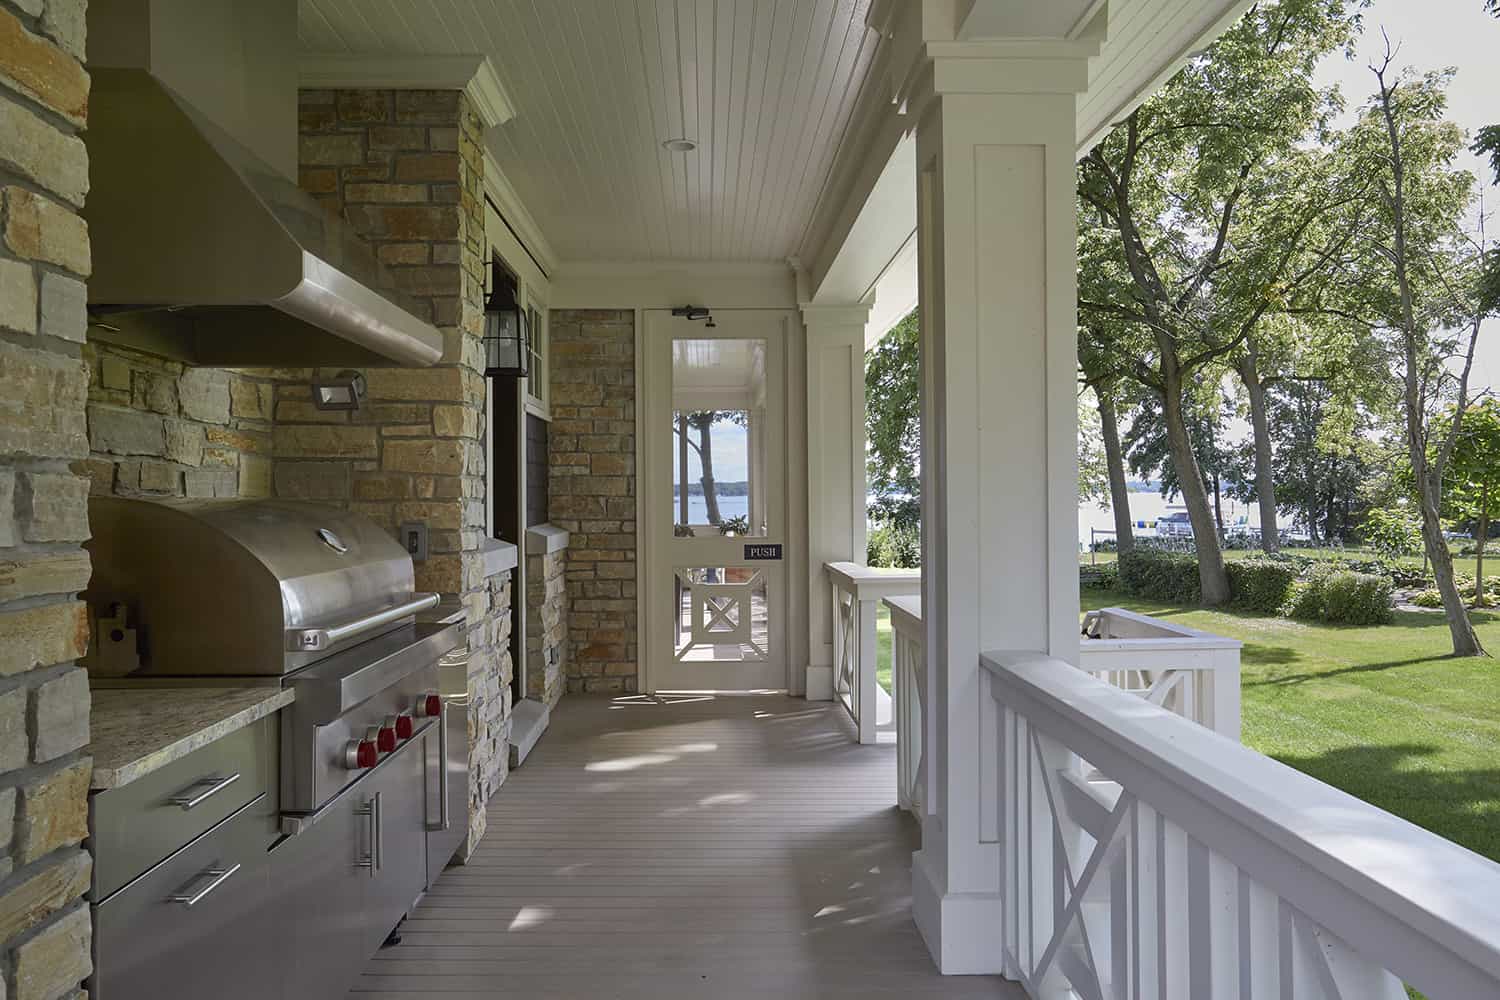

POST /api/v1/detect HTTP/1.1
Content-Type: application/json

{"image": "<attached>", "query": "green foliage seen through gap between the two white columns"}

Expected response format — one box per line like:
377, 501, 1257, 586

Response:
864, 310, 923, 529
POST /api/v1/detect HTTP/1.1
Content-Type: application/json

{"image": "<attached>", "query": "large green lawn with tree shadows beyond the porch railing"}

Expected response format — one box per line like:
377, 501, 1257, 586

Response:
1083, 589, 1500, 861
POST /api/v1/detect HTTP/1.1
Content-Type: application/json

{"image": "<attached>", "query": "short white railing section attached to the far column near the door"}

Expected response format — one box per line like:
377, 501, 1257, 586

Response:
824, 562, 923, 744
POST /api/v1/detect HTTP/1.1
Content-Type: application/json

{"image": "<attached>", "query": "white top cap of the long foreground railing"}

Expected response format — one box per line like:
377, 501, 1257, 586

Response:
981, 651, 1500, 985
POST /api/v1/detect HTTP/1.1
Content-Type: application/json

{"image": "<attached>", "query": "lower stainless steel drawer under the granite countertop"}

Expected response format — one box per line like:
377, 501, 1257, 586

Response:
90, 805, 278, 1000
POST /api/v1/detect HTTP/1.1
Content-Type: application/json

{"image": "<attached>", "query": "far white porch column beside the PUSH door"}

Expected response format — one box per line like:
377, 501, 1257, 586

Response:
803, 304, 870, 702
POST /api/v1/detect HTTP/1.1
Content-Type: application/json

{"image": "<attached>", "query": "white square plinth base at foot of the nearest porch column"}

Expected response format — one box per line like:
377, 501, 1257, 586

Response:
912, 850, 1005, 976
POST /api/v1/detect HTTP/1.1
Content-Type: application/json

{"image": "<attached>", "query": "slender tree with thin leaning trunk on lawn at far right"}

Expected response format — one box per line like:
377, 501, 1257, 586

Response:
1347, 56, 1485, 657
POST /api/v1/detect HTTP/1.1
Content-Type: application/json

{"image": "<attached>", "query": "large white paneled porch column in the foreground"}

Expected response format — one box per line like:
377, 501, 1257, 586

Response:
908, 39, 1088, 973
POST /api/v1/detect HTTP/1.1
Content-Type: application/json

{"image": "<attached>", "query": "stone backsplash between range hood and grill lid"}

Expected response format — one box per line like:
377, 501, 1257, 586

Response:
84, 343, 276, 499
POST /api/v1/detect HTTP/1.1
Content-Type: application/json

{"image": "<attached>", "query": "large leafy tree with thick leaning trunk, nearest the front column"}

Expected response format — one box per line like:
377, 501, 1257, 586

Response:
1079, 0, 1358, 606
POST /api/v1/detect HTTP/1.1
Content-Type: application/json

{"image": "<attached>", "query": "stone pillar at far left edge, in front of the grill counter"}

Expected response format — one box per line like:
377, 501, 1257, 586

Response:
0, 0, 92, 1000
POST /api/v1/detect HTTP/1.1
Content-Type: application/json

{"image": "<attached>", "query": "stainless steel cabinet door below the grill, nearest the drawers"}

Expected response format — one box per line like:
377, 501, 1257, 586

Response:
261, 795, 374, 1000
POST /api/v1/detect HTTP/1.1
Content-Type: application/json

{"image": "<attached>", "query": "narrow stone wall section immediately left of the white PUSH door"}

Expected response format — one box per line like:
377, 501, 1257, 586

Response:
548, 309, 639, 691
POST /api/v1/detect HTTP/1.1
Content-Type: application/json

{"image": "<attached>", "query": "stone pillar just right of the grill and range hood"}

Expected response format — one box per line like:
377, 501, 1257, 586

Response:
292, 90, 513, 856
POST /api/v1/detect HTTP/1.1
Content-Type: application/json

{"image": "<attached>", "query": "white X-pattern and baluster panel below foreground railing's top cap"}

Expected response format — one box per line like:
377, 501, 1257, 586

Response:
999, 699, 1406, 1000
